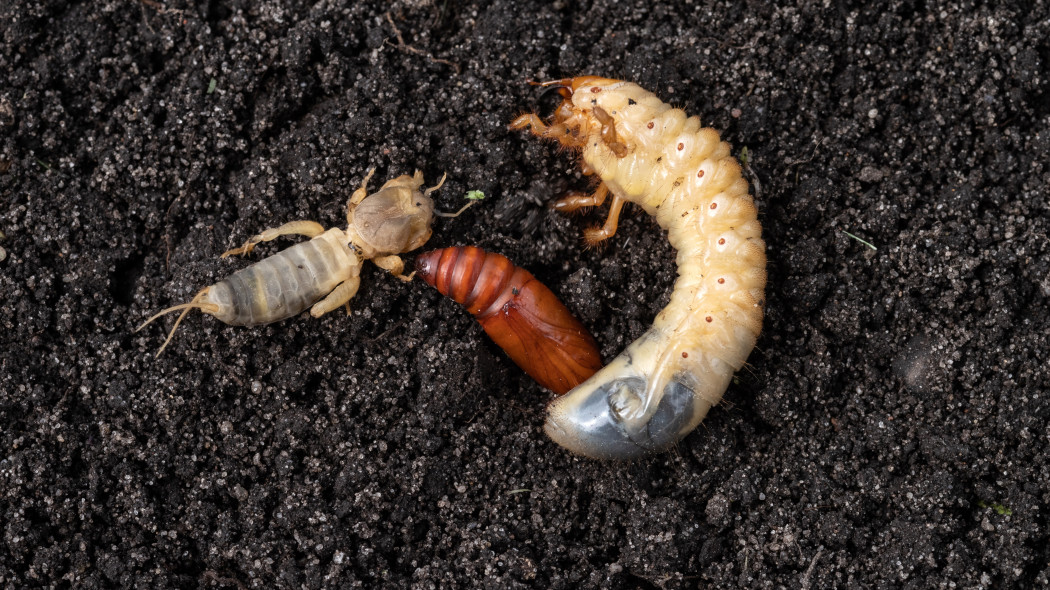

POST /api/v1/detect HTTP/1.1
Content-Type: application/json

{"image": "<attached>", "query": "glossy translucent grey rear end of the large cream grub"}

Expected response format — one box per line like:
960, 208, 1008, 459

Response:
544, 358, 698, 461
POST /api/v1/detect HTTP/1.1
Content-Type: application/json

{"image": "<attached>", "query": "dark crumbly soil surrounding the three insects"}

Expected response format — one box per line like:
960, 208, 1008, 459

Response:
0, 0, 1050, 589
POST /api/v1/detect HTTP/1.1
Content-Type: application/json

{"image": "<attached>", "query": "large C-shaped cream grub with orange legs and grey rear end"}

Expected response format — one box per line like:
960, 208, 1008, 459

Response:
510, 77, 765, 459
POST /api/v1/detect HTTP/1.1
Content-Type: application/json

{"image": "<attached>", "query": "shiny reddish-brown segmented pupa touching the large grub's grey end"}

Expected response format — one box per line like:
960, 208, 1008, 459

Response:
416, 246, 602, 395
